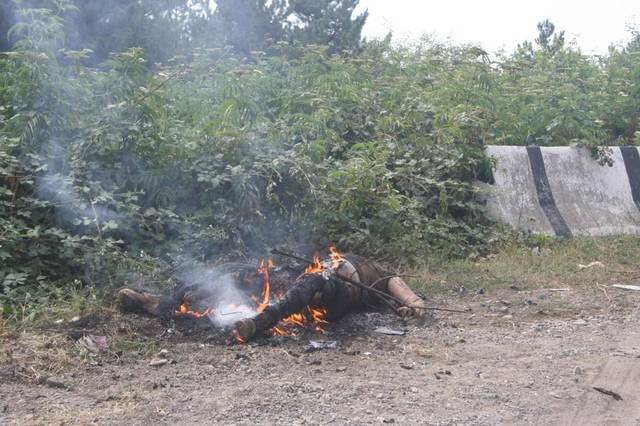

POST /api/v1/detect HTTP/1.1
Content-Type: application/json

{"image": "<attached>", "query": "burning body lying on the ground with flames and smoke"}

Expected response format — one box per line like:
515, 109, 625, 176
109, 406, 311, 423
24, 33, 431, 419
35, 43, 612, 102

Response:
118, 248, 426, 342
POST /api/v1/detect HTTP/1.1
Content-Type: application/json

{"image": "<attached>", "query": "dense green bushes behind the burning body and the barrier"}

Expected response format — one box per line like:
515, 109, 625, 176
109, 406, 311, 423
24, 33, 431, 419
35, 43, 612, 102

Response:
0, 1, 640, 311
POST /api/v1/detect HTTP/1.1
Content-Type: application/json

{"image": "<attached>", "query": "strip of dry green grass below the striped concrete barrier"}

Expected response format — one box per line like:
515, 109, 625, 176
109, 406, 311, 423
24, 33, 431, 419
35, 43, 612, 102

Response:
410, 236, 640, 293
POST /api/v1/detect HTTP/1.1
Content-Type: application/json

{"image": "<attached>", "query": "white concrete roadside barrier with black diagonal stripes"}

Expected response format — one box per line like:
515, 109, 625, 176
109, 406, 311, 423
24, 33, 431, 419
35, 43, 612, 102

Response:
481, 145, 640, 236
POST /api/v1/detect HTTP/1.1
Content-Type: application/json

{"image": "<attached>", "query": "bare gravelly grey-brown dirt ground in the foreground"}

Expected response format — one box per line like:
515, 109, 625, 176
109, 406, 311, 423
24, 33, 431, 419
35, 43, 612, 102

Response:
0, 286, 640, 425
